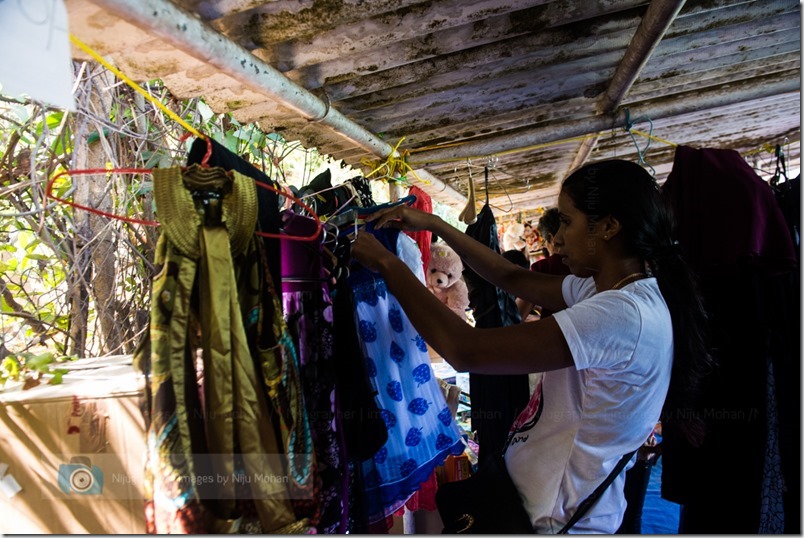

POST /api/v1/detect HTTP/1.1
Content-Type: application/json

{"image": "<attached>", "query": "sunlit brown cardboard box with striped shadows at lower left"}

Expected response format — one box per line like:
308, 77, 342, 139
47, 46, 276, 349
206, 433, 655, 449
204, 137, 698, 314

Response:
0, 357, 145, 534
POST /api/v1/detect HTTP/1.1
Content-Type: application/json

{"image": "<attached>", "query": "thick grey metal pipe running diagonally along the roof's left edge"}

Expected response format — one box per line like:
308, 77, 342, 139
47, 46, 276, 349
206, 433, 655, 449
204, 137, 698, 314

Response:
91, 0, 394, 159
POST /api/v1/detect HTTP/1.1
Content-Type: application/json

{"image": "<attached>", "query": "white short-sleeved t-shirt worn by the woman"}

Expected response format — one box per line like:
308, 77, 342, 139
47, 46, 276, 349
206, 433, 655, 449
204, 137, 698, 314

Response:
505, 275, 673, 534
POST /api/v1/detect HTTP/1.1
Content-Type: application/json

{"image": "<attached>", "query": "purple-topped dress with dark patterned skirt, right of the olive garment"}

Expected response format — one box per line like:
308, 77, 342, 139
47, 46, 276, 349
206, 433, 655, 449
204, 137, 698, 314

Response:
282, 211, 348, 534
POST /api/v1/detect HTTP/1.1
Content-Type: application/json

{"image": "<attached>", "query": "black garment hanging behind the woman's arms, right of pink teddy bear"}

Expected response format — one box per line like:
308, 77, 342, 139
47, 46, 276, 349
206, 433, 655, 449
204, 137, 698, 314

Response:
463, 202, 530, 464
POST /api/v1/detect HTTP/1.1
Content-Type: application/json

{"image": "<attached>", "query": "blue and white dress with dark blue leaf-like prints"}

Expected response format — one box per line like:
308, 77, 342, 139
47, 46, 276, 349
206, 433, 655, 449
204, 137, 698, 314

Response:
349, 223, 464, 523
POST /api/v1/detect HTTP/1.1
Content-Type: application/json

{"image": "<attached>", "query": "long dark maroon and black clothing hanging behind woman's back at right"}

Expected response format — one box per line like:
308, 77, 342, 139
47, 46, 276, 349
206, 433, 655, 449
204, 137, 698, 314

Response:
662, 146, 801, 534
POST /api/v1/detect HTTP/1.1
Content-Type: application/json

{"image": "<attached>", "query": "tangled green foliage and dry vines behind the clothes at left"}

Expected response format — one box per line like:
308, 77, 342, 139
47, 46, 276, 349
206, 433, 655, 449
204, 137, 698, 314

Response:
0, 63, 356, 358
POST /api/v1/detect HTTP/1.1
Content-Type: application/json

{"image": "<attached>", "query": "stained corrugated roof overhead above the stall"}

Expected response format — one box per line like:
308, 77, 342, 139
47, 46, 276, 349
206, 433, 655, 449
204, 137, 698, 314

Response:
66, 0, 801, 218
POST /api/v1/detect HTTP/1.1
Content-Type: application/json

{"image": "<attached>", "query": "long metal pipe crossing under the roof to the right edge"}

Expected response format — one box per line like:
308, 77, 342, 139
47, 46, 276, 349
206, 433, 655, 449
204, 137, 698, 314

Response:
408, 73, 801, 167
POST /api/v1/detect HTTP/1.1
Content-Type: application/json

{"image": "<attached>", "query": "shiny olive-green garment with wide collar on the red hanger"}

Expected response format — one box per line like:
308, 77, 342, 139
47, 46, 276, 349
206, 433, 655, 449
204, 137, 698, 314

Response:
135, 165, 309, 533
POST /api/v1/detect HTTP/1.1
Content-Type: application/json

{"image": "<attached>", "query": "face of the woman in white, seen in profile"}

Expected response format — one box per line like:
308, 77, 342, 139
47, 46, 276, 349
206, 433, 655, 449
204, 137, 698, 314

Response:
553, 191, 601, 277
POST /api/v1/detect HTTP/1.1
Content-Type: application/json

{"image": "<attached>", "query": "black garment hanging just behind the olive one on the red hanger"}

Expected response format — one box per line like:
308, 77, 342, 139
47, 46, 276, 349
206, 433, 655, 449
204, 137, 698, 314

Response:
187, 138, 282, 286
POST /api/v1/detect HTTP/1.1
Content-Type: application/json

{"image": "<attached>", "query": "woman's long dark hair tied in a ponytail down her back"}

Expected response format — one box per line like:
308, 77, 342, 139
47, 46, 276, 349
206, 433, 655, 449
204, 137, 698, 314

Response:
561, 160, 714, 446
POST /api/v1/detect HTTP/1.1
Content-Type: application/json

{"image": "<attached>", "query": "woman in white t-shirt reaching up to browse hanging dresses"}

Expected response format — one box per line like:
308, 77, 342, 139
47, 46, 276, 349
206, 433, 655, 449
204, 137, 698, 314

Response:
352, 160, 711, 533
